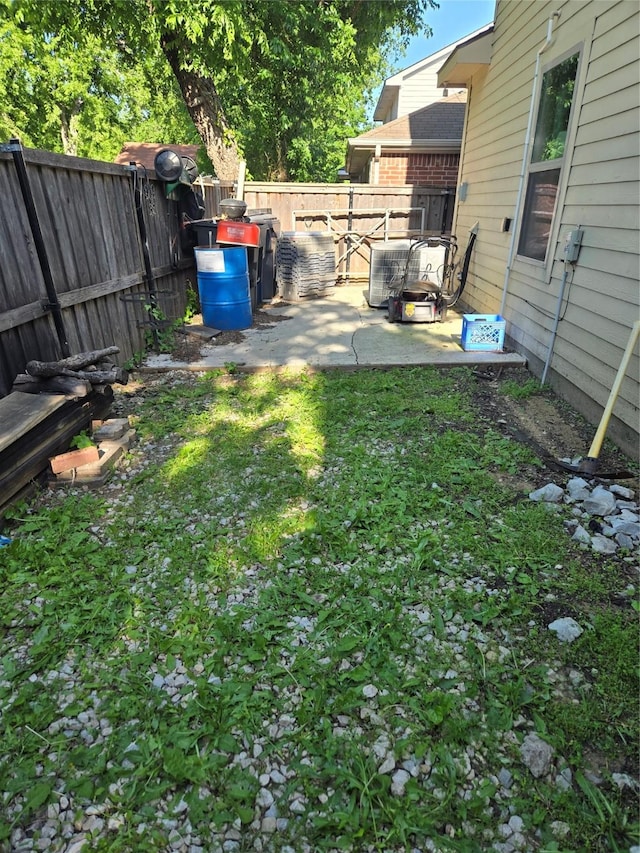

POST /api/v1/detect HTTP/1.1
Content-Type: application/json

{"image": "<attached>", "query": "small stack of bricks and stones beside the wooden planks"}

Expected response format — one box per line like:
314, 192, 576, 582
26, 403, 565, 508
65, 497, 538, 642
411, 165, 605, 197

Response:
49, 418, 135, 486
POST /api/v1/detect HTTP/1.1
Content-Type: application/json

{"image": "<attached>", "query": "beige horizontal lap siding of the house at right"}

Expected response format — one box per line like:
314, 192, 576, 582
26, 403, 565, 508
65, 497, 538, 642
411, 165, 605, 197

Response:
454, 0, 640, 454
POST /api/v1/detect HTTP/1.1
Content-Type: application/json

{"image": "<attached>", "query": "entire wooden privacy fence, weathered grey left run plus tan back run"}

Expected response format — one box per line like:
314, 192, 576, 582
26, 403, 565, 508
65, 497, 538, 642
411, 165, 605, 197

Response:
0, 140, 453, 397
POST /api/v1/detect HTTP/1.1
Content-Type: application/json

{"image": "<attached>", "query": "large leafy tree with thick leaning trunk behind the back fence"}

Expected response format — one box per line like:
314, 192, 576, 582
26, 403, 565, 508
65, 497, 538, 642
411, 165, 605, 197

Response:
5, 0, 435, 179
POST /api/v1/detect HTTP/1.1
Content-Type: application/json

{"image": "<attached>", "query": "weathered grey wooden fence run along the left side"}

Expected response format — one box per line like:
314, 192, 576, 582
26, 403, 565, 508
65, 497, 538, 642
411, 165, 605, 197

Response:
0, 140, 195, 396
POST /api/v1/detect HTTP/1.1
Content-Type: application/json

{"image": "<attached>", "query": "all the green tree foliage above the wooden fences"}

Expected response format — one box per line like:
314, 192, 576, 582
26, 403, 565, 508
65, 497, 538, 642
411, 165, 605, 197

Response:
0, 0, 435, 181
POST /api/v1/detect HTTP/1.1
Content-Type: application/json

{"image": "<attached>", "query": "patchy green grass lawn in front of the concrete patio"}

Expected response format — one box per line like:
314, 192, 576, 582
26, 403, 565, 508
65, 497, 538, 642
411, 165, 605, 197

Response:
0, 369, 638, 853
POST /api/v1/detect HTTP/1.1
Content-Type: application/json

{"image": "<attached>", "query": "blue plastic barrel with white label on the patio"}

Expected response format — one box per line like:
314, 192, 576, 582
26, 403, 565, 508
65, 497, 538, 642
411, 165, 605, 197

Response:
194, 246, 252, 331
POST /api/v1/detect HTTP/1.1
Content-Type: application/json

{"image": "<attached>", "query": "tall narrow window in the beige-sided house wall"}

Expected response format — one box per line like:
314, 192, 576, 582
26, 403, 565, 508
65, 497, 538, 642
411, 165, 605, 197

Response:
518, 53, 580, 261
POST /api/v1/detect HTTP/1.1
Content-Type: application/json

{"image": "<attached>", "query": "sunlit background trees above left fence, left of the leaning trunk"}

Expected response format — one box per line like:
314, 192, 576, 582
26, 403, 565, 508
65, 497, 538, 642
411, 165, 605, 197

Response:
0, 0, 198, 160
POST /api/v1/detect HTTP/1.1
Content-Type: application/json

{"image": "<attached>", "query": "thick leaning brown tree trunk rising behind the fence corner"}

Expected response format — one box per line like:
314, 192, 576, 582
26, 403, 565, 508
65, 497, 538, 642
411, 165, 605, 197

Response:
161, 37, 241, 181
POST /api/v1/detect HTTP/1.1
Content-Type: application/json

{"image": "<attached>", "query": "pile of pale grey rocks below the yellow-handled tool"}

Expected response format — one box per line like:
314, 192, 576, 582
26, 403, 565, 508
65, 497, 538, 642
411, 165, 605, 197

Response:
529, 477, 640, 554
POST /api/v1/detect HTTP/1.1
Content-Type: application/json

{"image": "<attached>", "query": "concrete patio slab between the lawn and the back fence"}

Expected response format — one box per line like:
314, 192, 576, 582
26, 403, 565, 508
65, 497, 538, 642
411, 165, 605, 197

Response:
143, 284, 526, 371
